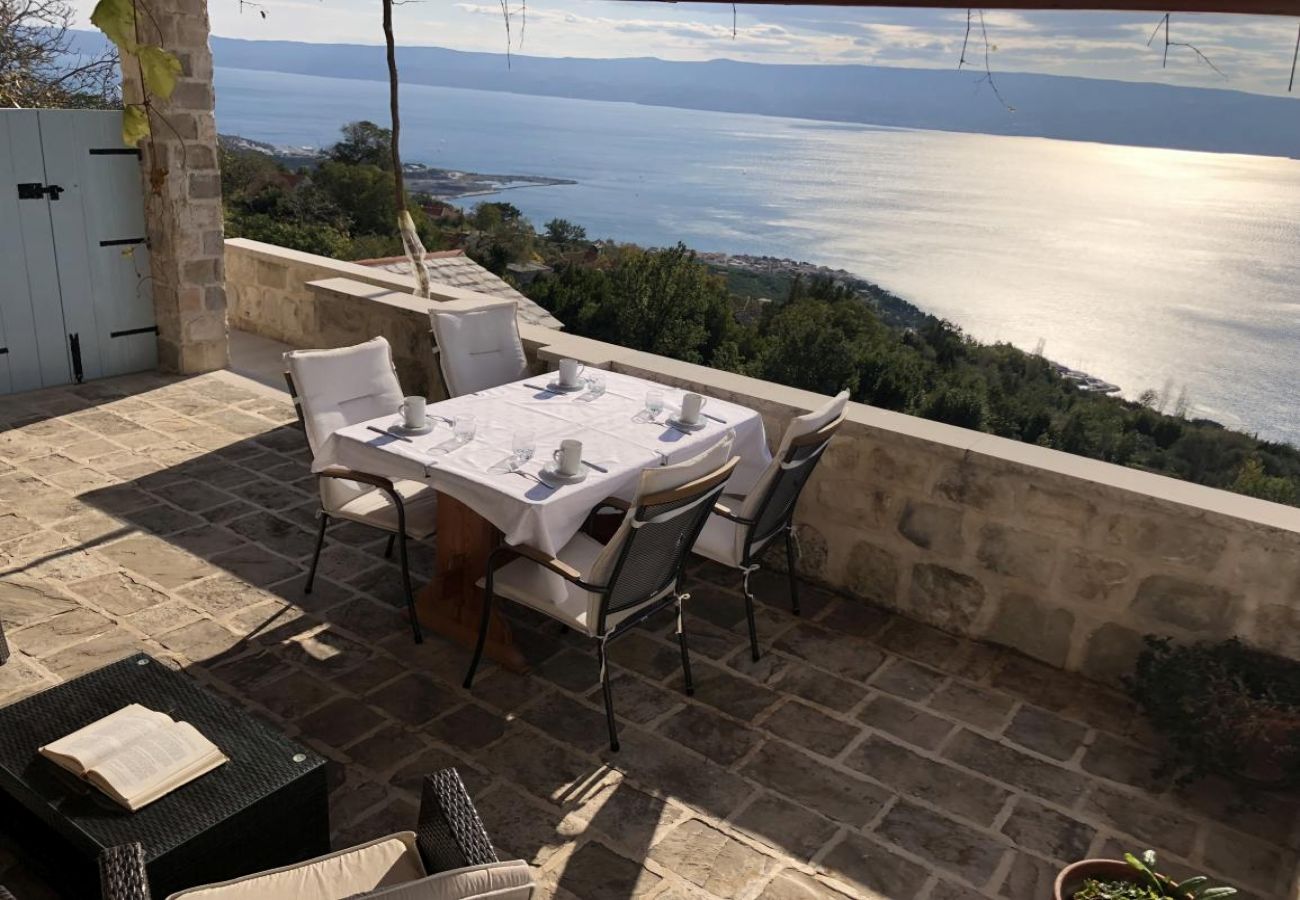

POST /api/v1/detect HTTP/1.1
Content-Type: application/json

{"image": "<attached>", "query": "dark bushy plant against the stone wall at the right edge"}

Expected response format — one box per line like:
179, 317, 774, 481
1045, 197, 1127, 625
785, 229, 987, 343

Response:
1125, 636, 1300, 783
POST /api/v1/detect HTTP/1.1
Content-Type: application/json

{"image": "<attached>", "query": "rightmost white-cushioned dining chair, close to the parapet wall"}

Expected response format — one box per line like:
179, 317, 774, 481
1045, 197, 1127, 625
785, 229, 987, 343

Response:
696, 390, 849, 661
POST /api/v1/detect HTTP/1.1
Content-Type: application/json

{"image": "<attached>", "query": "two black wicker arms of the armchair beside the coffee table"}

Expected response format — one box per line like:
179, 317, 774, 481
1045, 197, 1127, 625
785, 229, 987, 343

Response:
83, 769, 499, 900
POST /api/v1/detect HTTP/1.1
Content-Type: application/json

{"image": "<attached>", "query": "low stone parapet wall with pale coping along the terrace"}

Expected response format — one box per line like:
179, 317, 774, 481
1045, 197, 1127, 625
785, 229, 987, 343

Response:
226, 241, 1300, 682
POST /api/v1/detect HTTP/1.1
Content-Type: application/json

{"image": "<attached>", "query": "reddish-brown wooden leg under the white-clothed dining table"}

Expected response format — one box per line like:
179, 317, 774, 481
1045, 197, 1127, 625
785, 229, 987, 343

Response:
415, 492, 528, 672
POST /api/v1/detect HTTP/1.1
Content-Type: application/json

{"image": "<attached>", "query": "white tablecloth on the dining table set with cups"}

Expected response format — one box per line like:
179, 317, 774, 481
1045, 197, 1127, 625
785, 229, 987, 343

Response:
313, 372, 771, 554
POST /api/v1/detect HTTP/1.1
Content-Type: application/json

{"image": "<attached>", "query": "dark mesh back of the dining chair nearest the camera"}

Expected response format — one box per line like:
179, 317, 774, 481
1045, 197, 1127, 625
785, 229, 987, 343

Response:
598, 457, 740, 633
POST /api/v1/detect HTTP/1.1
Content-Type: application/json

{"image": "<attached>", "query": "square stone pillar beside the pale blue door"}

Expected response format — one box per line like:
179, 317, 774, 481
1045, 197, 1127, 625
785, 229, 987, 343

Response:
122, 0, 230, 375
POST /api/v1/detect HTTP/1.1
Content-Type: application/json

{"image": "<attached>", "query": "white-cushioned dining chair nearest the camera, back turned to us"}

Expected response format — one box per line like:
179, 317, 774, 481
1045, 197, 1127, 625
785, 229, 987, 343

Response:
465, 433, 740, 750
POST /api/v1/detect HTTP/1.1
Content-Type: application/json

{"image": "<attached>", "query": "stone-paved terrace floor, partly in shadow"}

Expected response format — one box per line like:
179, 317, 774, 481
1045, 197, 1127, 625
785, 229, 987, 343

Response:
0, 372, 1297, 900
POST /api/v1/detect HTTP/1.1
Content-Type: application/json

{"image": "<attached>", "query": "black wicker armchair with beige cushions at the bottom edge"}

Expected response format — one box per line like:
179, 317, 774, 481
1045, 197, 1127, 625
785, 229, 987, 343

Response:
90, 769, 533, 900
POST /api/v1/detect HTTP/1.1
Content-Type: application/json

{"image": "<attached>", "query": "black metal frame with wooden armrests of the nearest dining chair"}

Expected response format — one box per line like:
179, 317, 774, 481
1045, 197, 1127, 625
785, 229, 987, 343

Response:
464, 457, 740, 753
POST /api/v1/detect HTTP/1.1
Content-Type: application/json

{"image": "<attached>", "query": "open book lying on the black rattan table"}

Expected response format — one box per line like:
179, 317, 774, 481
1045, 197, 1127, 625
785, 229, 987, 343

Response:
40, 704, 228, 812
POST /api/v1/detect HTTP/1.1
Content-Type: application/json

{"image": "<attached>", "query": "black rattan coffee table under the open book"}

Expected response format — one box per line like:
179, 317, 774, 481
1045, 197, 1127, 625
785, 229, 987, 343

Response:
0, 653, 329, 899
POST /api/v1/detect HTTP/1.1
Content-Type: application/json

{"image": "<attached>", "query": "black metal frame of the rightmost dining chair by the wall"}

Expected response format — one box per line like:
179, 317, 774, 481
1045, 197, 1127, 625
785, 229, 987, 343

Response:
714, 415, 844, 662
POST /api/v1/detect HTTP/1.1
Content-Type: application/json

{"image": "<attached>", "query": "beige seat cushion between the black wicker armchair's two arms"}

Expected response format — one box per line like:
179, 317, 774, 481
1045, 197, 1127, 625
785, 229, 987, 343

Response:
168, 831, 426, 900
